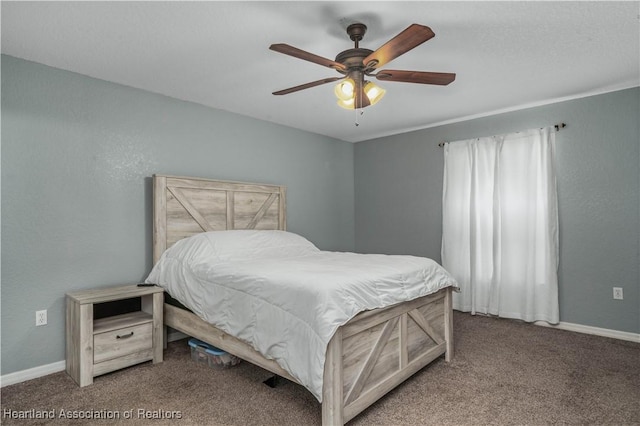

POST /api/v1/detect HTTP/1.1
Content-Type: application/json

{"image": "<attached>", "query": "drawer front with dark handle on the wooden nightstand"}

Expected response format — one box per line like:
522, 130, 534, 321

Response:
93, 322, 153, 364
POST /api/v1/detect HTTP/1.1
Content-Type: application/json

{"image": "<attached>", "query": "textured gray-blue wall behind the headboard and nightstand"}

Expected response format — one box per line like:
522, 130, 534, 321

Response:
1, 56, 354, 374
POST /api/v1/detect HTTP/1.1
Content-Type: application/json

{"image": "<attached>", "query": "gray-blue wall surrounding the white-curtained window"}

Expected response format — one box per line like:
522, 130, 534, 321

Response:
354, 88, 640, 333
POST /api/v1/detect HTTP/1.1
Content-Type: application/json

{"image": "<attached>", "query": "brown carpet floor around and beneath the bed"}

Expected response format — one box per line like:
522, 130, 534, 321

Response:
0, 312, 640, 425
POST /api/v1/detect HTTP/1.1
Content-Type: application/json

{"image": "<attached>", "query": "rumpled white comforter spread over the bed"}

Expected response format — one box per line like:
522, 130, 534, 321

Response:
147, 231, 457, 401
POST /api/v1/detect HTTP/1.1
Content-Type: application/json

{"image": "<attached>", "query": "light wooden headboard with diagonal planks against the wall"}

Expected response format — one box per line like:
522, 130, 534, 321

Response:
153, 175, 286, 264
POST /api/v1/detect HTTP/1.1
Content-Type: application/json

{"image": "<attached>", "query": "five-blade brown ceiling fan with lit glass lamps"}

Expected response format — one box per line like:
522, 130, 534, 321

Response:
269, 23, 456, 109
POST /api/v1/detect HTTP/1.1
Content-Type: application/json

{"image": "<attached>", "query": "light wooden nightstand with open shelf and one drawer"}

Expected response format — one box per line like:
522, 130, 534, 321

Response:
66, 284, 164, 386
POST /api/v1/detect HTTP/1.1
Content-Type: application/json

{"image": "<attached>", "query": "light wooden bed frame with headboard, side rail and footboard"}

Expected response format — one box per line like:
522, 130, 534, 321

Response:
153, 175, 453, 425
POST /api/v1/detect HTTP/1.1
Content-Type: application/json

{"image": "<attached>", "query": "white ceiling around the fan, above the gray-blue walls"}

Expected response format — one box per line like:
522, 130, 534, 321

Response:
1, 1, 640, 142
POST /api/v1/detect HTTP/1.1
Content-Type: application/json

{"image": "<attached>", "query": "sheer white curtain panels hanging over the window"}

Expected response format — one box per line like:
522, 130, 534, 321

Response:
442, 127, 559, 324
